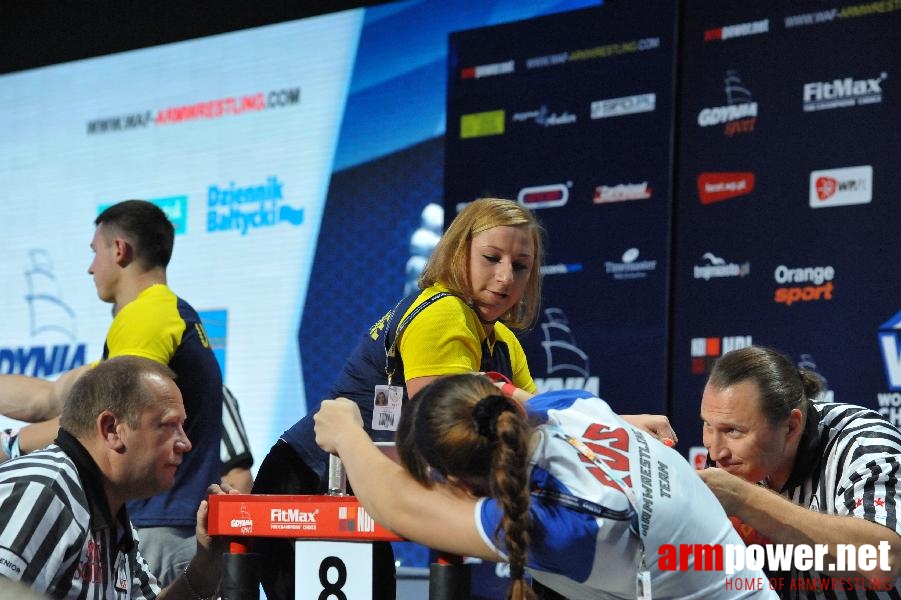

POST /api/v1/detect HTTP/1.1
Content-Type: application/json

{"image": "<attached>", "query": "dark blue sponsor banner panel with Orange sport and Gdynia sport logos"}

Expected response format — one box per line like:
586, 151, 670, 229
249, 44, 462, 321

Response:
669, 0, 901, 448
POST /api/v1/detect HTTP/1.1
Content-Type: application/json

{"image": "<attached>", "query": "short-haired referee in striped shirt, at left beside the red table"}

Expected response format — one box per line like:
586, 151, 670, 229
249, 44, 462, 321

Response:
0, 356, 229, 600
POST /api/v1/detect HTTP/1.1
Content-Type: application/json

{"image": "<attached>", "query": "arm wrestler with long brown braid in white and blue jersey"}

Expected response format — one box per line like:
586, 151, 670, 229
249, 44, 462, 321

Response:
315, 374, 775, 600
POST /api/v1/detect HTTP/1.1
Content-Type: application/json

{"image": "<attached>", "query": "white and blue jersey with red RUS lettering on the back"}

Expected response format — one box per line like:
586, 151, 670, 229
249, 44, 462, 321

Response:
476, 390, 776, 600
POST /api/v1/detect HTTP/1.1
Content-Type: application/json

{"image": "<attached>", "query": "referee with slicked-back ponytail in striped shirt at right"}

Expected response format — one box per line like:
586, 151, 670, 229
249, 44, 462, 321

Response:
700, 346, 901, 598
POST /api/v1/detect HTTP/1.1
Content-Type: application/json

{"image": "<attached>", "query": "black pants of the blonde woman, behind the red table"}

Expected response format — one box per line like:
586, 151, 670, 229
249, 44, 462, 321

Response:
251, 440, 397, 600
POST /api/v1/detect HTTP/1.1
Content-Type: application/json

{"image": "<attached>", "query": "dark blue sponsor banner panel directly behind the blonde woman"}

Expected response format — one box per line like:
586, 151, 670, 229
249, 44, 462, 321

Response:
444, 1, 675, 422
